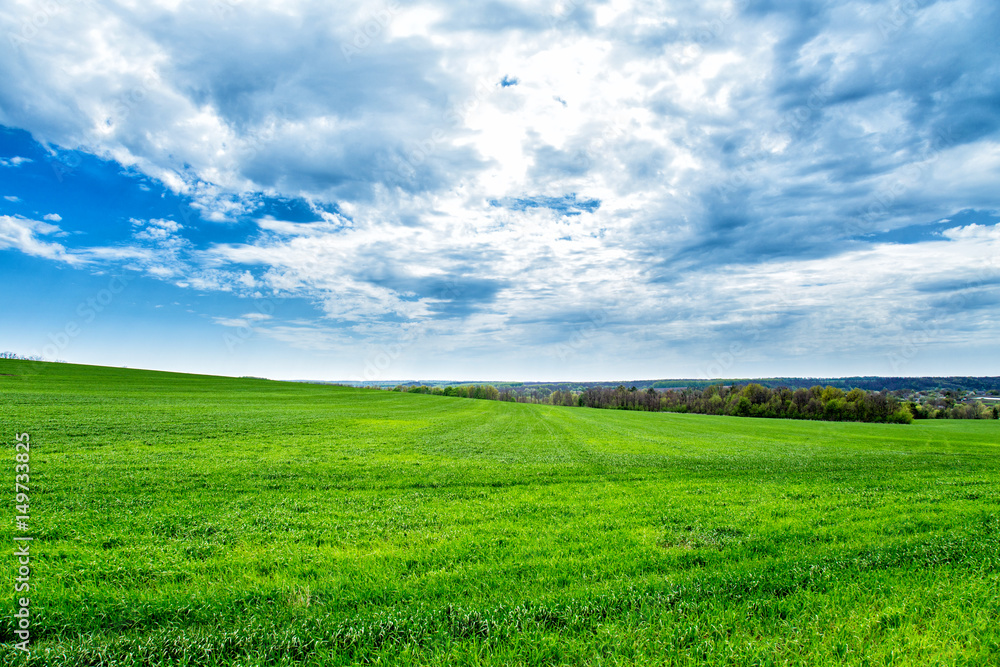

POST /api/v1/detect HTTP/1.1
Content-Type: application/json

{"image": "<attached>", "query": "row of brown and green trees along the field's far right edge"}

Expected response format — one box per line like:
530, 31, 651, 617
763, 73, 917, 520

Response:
394, 382, 1000, 424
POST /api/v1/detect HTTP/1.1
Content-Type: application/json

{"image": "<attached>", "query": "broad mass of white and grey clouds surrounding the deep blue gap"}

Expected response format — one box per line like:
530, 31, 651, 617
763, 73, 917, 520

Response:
0, 0, 1000, 376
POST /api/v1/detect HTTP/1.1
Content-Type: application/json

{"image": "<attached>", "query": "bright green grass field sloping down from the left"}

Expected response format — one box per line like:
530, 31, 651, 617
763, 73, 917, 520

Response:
0, 361, 1000, 666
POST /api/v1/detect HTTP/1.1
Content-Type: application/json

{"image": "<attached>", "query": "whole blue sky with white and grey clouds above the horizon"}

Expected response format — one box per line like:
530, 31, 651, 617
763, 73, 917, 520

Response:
0, 0, 1000, 381
